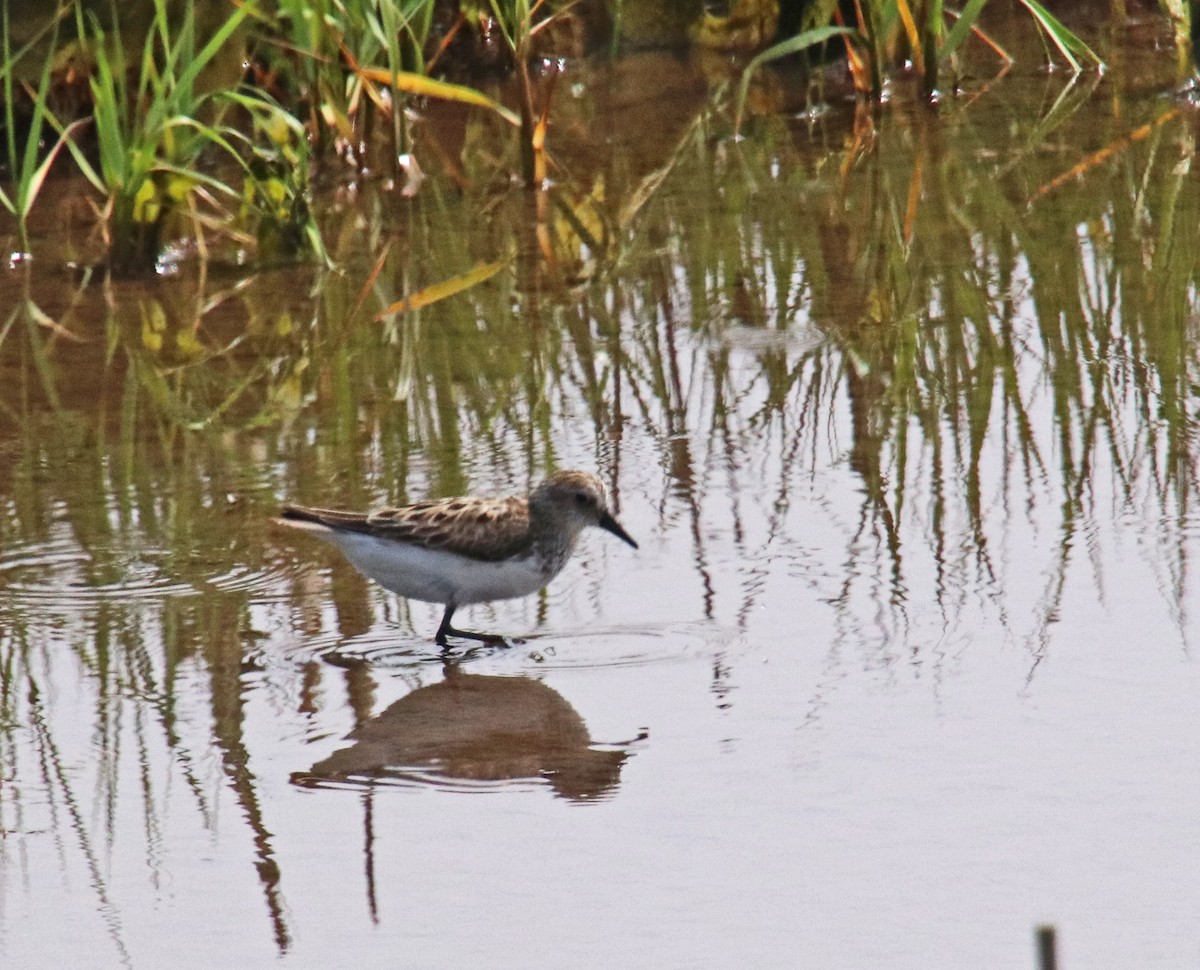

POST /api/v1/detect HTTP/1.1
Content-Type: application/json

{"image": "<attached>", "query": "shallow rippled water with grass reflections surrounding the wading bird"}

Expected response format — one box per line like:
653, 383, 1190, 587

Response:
0, 7, 1200, 969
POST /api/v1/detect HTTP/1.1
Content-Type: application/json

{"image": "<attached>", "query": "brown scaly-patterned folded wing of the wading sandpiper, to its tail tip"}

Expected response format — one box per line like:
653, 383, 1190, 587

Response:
283, 498, 529, 562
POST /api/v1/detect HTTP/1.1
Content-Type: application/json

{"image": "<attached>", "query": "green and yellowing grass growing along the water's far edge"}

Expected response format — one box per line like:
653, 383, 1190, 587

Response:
0, 0, 1137, 275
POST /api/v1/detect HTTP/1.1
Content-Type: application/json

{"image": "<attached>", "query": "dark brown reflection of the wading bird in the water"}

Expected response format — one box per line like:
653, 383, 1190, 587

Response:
293, 664, 644, 802
